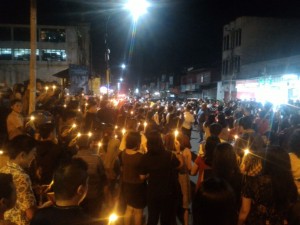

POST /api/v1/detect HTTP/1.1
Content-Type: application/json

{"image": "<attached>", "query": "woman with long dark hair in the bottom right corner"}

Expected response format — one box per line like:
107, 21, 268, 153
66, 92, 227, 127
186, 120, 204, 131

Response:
238, 146, 297, 225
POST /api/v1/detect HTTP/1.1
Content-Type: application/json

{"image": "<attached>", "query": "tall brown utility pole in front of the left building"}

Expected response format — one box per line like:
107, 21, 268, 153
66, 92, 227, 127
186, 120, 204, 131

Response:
29, 0, 36, 113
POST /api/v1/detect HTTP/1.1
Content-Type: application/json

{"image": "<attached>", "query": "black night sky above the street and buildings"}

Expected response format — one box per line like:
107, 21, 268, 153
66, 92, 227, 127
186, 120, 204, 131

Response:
0, 0, 300, 83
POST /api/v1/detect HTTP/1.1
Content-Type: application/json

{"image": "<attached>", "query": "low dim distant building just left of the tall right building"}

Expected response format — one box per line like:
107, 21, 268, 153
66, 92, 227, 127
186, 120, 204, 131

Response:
180, 68, 221, 99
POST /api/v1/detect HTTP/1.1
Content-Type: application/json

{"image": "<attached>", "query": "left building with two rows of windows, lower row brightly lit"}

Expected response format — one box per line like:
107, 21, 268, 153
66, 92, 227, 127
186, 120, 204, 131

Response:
0, 24, 90, 86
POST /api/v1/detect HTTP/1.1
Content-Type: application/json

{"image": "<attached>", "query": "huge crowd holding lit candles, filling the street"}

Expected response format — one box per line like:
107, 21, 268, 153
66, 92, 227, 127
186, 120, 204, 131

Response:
0, 81, 300, 225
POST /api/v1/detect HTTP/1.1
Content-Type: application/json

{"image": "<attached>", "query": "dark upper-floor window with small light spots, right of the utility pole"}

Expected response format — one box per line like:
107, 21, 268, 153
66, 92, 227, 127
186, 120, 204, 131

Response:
40, 28, 66, 42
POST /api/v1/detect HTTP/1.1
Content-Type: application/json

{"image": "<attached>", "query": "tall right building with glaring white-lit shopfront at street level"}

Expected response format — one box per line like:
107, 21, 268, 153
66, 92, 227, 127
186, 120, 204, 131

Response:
218, 17, 300, 101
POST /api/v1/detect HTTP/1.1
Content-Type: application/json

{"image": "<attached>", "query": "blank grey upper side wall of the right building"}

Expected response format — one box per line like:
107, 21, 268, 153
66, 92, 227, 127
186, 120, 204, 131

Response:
222, 17, 300, 80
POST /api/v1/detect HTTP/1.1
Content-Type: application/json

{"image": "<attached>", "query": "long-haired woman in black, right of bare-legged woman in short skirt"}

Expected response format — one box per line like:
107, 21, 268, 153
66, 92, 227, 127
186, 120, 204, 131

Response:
140, 131, 180, 225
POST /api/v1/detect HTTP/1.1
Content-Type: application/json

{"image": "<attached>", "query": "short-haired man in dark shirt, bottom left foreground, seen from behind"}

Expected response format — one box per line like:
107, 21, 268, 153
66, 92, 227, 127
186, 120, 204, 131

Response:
30, 158, 98, 225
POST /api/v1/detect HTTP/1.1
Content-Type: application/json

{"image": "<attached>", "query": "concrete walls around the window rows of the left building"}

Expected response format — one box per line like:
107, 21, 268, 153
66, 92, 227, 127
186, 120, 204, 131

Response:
0, 24, 90, 87
